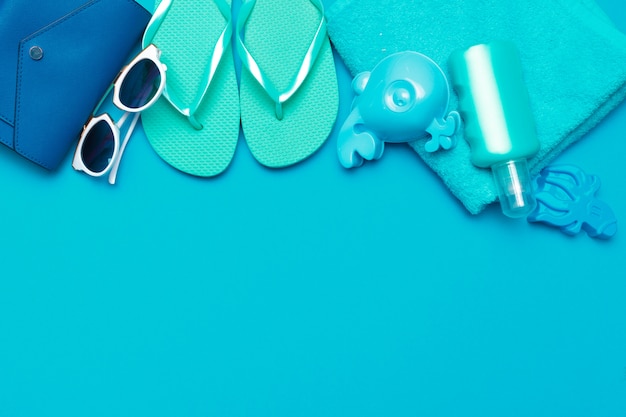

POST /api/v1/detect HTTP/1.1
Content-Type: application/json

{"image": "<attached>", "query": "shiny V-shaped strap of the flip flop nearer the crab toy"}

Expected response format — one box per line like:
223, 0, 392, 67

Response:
235, 0, 326, 120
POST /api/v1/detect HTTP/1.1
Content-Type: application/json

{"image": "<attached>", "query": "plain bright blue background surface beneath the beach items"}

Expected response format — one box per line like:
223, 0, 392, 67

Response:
0, 0, 626, 417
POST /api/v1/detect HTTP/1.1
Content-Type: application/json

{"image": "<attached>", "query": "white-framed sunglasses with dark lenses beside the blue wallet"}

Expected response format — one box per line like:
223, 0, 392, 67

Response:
72, 44, 167, 184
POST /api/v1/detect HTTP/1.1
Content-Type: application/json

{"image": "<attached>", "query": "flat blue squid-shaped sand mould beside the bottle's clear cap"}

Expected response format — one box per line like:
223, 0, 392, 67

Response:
527, 165, 617, 239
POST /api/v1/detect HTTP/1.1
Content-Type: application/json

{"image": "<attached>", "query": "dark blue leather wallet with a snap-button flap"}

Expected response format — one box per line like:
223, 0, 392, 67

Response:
0, 0, 150, 169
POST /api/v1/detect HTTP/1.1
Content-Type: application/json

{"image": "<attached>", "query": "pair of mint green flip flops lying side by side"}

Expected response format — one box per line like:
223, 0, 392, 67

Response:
142, 0, 339, 177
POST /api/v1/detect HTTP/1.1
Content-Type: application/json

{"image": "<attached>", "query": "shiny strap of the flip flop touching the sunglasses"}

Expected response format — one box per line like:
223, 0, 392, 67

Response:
141, 0, 233, 130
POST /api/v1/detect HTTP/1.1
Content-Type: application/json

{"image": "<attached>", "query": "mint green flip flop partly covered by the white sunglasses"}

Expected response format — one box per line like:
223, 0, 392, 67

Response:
142, 0, 240, 177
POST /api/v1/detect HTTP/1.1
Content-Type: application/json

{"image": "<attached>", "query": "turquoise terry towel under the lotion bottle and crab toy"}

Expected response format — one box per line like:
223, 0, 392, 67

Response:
327, 0, 626, 214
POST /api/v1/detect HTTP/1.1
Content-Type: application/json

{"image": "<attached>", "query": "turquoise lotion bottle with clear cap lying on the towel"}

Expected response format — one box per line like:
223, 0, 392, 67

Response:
448, 41, 539, 218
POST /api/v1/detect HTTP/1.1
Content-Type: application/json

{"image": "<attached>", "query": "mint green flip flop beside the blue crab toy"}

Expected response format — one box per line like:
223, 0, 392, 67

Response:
235, 0, 339, 168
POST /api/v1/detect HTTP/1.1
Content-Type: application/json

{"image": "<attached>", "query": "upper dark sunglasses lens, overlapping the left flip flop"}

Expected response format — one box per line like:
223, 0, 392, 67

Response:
120, 59, 162, 109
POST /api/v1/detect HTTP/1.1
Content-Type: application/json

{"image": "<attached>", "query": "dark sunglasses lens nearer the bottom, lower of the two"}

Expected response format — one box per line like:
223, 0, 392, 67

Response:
81, 120, 115, 173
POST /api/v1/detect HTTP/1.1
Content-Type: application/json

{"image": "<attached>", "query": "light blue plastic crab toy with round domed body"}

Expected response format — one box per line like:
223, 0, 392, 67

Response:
337, 51, 461, 168
